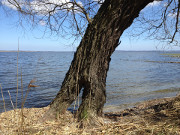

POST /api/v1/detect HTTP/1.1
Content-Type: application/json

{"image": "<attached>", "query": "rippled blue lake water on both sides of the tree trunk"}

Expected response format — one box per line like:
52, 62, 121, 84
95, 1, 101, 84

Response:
0, 51, 180, 112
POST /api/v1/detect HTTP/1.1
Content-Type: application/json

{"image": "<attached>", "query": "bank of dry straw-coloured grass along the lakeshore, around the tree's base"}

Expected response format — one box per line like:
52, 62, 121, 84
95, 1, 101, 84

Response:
0, 96, 180, 135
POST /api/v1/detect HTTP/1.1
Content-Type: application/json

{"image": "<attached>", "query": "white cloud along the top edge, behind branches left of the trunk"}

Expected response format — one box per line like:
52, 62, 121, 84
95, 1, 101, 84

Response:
2, 0, 92, 16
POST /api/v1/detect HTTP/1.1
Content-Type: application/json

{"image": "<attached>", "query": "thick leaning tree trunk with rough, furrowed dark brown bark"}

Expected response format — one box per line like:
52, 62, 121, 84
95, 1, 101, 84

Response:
46, 0, 153, 123
